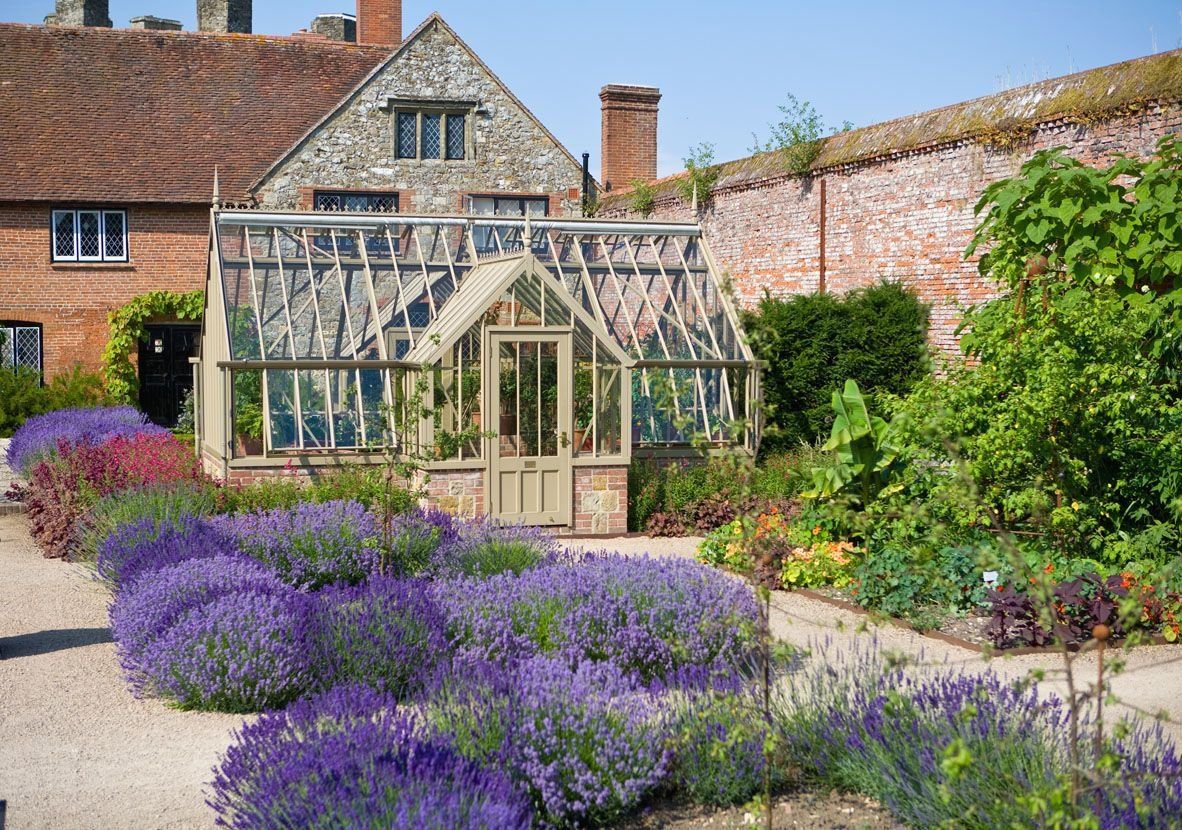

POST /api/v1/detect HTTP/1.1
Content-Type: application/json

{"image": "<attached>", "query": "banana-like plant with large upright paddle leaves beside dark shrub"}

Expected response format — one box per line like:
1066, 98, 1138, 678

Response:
804, 381, 900, 505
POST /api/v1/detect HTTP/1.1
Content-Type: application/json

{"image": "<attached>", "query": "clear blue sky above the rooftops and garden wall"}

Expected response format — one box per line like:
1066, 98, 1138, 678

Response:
9, 0, 1182, 175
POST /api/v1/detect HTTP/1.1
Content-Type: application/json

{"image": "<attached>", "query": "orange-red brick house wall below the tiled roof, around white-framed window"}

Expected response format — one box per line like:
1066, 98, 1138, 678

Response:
0, 202, 209, 375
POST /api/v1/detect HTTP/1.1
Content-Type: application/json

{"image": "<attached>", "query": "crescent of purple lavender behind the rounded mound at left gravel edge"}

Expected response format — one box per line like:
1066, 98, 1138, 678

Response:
110, 555, 292, 693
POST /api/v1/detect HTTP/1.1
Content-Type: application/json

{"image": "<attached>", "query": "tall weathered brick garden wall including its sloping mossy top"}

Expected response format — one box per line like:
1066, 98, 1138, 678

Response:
597, 50, 1182, 351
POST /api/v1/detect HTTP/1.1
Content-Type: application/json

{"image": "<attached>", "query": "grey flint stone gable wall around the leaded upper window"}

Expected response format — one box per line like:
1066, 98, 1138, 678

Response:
254, 17, 583, 215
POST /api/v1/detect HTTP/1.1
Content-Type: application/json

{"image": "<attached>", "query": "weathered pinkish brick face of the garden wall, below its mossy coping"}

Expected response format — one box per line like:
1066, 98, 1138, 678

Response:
599, 105, 1182, 349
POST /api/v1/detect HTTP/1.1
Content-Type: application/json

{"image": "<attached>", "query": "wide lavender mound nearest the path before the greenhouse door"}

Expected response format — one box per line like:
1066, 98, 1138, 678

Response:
436, 556, 758, 685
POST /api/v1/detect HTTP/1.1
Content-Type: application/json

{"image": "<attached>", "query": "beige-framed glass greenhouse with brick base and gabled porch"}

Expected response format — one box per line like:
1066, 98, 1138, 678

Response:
195, 210, 760, 531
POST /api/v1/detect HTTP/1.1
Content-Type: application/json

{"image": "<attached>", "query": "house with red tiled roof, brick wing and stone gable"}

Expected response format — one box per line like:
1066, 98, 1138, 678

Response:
0, 0, 655, 430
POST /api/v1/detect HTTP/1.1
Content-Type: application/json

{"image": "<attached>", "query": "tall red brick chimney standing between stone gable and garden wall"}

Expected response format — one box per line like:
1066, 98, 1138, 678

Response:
599, 84, 661, 190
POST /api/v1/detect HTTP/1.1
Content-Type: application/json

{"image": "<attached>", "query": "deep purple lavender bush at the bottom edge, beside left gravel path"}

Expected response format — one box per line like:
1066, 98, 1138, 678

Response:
209, 686, 532, 830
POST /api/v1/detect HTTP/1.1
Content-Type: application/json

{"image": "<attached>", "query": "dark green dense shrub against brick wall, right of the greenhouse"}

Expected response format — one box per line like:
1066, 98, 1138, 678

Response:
745, 283, 928, 453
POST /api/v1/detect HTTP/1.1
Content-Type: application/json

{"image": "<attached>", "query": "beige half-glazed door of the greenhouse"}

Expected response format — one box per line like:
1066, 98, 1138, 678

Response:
486, 329, 571, 525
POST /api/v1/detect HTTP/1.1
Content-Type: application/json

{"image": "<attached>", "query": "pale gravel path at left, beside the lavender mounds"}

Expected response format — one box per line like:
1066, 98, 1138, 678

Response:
0, 514, 242, 830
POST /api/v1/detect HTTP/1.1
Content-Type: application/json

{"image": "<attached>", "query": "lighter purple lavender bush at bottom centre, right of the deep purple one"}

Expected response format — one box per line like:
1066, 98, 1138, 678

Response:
427, 656, 669, 825
